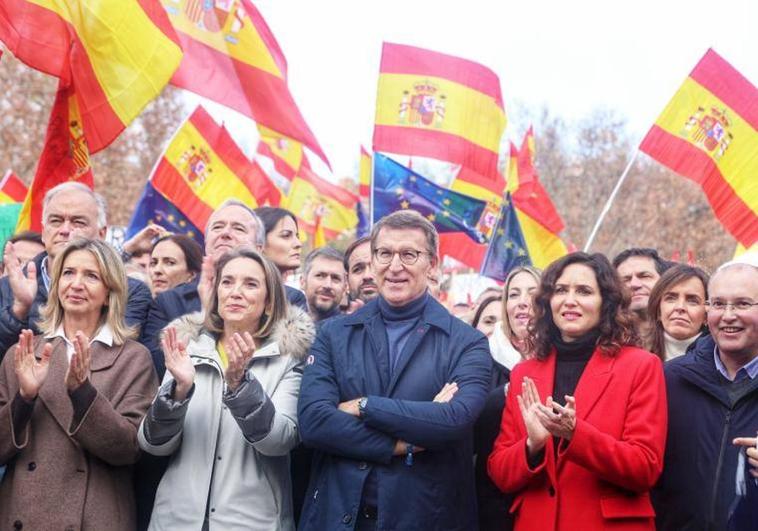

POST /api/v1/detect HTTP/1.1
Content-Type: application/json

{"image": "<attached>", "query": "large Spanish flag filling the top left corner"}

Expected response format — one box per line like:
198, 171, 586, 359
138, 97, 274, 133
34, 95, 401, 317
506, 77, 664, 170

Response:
0, 0, 182, 153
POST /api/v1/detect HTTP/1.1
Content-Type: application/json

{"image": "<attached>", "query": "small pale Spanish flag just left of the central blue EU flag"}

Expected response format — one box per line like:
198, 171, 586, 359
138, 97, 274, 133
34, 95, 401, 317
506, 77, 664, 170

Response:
281, 164, 358, 238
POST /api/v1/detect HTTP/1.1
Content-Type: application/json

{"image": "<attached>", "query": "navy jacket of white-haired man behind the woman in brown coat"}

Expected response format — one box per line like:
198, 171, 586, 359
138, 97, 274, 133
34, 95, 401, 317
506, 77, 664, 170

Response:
0, 252, 152, 360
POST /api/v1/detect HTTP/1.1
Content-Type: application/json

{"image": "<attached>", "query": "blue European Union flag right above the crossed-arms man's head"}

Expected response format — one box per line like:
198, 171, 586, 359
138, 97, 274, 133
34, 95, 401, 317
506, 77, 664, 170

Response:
372, 153, 487, 243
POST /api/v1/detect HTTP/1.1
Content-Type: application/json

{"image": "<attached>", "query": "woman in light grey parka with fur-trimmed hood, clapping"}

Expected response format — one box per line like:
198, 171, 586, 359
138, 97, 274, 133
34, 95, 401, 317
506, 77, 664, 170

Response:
139, 250, 314, 530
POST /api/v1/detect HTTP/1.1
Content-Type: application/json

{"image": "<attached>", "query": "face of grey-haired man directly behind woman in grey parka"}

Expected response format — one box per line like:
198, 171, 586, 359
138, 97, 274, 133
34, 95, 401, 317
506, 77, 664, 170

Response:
205, 205, 257, 260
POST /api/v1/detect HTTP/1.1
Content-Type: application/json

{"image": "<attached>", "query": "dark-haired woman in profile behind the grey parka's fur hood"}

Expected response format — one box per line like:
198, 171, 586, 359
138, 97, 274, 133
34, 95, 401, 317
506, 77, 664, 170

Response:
255, 207, 308, 310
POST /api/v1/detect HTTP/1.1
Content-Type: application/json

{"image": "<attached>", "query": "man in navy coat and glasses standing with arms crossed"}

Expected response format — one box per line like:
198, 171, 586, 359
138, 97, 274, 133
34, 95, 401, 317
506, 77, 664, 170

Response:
298, 210, 492, 531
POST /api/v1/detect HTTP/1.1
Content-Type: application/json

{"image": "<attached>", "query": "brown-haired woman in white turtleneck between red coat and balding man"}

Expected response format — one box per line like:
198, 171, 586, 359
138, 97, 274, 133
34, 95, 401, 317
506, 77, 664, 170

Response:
647, 264, 708, 361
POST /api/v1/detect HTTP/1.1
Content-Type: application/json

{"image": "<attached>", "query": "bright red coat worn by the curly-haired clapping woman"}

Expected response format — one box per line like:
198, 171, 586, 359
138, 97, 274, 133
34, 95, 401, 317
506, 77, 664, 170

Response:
488, 347, 667, 531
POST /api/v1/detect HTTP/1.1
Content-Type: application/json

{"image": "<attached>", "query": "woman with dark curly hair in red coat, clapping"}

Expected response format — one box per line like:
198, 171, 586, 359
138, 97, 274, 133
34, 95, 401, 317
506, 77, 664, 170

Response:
488, 253, 667, 531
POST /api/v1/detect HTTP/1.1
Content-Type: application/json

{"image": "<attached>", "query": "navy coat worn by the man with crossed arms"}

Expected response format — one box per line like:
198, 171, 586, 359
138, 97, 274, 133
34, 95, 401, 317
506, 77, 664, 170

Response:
298, 297, 492, 531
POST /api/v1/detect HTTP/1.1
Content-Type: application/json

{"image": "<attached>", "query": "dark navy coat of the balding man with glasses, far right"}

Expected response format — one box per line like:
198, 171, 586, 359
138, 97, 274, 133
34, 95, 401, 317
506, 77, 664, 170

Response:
652, 336, 758, 531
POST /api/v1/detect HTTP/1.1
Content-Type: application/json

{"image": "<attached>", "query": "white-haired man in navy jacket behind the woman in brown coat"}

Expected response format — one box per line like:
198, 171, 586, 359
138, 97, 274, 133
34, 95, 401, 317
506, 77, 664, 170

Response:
0, 181, 152, 359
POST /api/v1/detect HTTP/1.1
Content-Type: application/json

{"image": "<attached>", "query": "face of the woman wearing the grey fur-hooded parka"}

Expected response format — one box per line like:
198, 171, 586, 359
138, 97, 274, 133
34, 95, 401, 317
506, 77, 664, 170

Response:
218, 257, 268, 333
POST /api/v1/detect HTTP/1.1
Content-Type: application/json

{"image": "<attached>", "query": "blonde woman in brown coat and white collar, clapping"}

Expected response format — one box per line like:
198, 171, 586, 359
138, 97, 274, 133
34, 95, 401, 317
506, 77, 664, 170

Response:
0, 240, 158, 530
